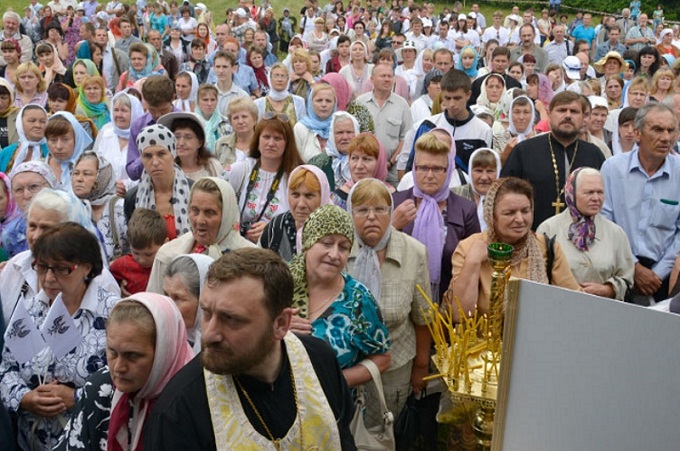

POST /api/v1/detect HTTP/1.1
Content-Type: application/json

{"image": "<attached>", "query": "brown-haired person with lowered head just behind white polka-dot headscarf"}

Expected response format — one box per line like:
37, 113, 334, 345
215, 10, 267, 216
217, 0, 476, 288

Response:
125, 75, 180, 180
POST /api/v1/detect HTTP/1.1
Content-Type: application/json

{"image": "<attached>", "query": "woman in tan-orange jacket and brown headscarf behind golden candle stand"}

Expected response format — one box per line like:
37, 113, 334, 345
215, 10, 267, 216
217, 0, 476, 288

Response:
452, 177, 580, 321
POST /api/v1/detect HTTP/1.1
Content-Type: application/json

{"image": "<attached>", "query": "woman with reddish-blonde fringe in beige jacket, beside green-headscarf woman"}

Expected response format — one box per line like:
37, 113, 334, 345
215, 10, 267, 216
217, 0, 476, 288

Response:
348, 179, 431, 413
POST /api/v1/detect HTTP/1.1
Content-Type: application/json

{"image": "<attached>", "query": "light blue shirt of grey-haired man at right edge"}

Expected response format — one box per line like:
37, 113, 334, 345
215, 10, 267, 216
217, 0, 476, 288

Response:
601, 150, 680, 279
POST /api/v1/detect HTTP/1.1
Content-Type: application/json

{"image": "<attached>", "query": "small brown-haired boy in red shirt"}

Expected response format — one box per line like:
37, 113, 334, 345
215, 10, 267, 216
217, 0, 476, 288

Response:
109, 208, 168, 297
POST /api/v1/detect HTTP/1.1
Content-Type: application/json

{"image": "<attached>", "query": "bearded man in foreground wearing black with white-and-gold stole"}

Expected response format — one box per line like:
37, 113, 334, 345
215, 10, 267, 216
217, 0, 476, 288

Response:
144, 249, 356, 451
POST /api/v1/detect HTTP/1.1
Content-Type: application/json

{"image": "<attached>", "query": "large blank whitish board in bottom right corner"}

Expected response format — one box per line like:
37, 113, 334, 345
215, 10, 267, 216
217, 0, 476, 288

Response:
494, 280, 680, 451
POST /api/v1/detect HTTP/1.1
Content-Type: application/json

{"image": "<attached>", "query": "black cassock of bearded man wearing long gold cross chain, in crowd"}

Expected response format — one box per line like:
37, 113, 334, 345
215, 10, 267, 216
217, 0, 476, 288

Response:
501, 133, 604, 230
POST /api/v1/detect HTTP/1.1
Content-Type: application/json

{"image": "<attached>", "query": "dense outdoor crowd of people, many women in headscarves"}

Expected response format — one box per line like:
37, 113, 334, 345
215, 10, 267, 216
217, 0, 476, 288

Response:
0, 0, 680, 450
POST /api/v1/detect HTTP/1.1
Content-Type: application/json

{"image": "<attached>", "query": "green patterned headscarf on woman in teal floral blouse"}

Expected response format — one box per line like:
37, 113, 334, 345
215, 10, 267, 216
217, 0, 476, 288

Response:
290, 205, 354, 318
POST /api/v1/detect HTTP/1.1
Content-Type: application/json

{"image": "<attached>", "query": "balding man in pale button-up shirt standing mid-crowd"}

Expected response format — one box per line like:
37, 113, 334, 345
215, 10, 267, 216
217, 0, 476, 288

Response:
357, 64, 413, 184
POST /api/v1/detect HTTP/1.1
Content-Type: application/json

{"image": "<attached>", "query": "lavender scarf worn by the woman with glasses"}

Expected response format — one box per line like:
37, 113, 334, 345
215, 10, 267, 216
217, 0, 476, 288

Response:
412, 130, 456, 284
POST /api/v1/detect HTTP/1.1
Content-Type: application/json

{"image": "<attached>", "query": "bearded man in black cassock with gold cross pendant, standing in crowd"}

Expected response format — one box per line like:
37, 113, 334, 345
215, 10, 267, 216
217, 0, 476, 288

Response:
501, 91, 604, 230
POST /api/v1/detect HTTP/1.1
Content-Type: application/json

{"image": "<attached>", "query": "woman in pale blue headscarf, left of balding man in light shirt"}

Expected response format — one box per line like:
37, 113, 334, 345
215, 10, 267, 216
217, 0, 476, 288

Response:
293, 83, 336, 162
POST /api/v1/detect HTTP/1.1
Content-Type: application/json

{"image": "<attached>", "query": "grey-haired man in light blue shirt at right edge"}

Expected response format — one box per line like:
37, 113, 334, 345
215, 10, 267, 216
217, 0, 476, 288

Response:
602, 103, 680, 305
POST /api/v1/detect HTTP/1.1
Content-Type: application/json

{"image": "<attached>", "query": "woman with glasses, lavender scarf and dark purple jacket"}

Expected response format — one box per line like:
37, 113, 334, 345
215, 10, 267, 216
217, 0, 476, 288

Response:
392, 132, 480, 301
